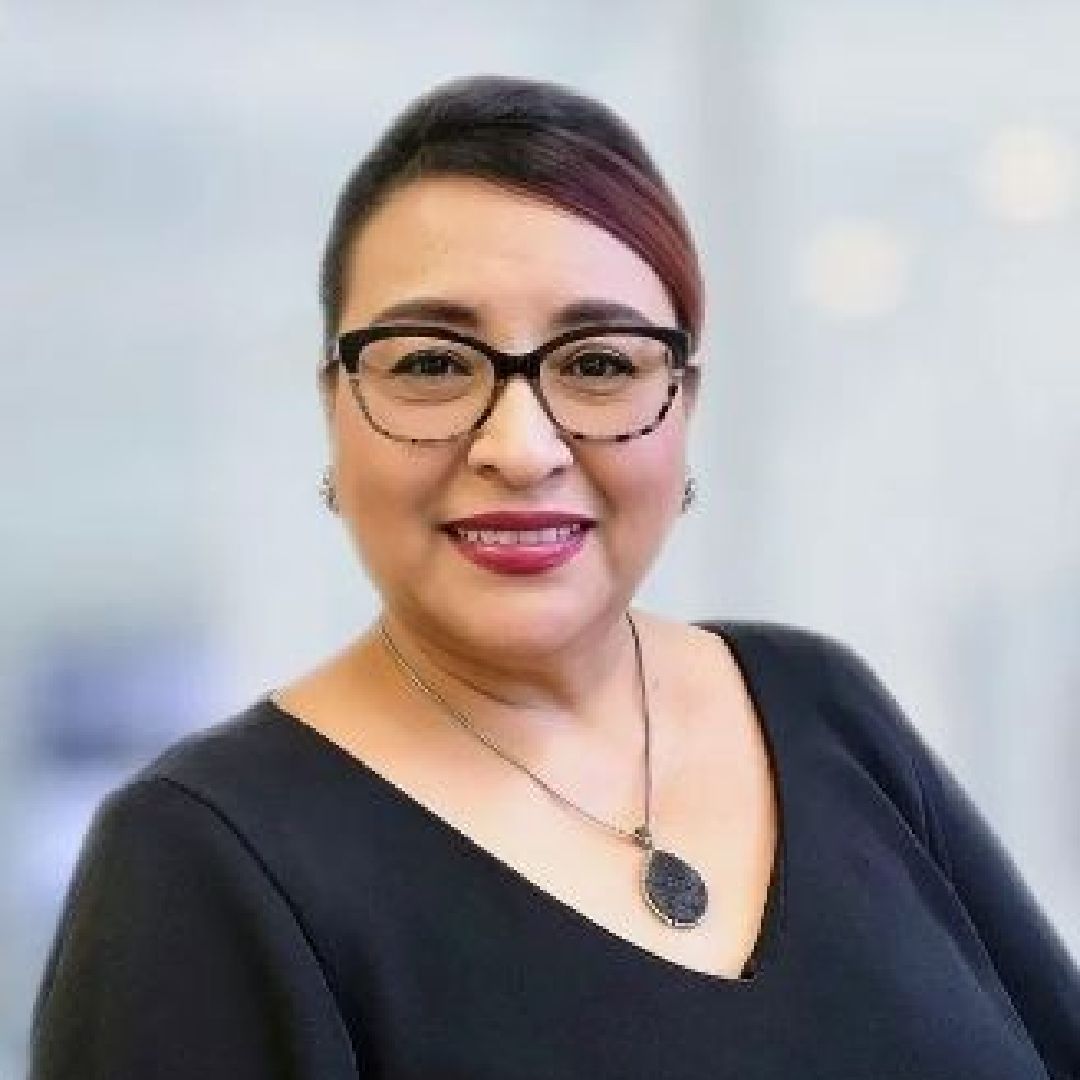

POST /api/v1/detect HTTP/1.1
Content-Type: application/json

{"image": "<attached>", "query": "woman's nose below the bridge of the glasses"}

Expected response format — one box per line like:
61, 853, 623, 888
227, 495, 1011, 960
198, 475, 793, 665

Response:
469, 376, 573, 487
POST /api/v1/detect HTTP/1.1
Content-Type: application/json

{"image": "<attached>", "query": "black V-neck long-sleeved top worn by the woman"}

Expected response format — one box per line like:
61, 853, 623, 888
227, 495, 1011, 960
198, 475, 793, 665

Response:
30, 622, 1080, 1080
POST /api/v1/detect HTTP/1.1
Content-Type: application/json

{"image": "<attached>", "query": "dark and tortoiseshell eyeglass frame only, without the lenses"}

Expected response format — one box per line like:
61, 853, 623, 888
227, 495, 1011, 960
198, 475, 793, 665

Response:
324, 323, 694, 445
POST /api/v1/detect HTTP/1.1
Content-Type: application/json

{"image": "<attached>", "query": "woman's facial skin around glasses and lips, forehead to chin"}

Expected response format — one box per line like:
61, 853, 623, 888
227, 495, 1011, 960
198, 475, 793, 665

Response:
328, 177, 692, 653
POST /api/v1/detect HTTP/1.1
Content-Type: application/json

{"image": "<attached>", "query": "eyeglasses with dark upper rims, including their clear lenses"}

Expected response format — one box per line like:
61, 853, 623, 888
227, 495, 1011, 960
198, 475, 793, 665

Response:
330, 324, 690, 443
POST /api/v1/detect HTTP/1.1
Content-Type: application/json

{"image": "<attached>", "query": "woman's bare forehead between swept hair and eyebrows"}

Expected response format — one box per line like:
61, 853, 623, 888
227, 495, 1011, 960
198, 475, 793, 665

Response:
342, 177, 676, 328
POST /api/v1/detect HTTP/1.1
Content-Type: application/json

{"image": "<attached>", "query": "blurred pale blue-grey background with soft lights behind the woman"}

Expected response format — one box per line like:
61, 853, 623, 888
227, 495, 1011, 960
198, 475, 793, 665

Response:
0, 0, 1080, 1077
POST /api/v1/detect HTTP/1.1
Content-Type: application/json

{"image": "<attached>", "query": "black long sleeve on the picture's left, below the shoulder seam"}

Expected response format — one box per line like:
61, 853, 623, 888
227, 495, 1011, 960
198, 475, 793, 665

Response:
29, 778, 360, 1080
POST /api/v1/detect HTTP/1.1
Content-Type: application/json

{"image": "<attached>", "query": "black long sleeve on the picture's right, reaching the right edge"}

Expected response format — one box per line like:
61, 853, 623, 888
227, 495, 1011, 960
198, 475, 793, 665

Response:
820, 646, 1080, 1080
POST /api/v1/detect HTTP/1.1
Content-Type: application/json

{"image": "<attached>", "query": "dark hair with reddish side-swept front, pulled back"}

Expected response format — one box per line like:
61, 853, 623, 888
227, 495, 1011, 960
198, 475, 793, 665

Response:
320, 76, 702, 380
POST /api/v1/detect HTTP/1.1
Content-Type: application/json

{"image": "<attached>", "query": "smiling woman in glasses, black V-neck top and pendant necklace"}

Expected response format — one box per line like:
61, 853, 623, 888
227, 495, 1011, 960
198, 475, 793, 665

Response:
32, 77, 1080, 1080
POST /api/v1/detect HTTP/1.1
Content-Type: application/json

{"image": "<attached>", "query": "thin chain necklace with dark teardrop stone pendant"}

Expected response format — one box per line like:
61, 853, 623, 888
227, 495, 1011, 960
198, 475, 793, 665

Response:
379, 611, 708, 929
